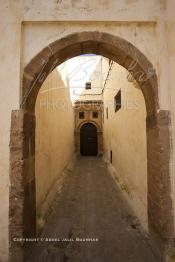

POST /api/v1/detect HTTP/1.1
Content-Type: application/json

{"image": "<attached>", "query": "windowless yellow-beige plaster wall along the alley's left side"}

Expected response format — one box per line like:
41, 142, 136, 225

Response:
35, 69, 74, 226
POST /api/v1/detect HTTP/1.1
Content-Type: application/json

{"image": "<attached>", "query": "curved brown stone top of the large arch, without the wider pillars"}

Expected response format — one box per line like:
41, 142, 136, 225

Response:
21, 32, 159, 115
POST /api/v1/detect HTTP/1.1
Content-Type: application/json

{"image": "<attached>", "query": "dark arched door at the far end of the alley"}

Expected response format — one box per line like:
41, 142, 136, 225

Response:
80, 123, 98, 156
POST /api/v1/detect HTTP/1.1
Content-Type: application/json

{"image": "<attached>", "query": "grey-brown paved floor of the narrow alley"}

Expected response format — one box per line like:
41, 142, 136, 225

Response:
25, 157, 159, 262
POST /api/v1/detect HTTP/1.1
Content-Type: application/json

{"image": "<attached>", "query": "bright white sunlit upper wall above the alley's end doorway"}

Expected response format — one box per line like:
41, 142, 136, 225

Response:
58, 54, 102, 101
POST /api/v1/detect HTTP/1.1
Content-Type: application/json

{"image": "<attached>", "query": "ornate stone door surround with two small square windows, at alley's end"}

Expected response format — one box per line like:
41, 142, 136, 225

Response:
74, 100, 103, 156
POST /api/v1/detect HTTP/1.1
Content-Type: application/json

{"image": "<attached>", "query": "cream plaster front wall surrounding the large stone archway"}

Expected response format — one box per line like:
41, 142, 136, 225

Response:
0, 0, 175, 262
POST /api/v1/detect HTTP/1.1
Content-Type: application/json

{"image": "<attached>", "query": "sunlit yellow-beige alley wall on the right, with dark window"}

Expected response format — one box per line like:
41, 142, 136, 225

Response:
103, 58, 148, 230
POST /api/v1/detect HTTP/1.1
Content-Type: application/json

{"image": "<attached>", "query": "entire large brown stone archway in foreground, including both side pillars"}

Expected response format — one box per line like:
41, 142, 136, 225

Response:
10, 32, 173, 261
